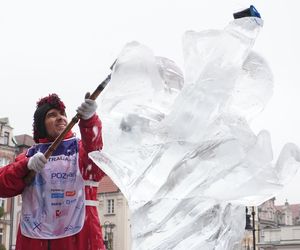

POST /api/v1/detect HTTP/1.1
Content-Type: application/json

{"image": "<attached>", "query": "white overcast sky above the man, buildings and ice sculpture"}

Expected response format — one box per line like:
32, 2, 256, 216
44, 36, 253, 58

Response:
0, 0, 300, 204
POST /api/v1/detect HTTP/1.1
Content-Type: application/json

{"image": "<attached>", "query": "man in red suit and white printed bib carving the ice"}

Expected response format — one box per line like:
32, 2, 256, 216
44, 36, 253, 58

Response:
0, 94, 105, 250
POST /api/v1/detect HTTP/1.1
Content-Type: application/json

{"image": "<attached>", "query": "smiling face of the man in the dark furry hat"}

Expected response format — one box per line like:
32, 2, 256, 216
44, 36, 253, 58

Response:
45, 109, 68, 140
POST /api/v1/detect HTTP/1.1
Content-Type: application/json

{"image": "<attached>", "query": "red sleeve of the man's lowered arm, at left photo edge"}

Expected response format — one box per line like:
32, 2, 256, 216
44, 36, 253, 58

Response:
0, 154, 28, 198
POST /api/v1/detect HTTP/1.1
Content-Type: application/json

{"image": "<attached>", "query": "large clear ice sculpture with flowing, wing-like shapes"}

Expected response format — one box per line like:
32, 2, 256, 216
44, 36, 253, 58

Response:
90, 17, 300, 250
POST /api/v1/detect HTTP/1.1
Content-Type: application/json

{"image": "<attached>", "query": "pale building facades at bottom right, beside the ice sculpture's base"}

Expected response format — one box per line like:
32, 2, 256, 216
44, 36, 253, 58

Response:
240, 198, 300, 250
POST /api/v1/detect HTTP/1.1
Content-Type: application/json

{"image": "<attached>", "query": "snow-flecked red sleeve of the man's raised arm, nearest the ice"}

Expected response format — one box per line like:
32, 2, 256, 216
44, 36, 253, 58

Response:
79, 114, 105, 181
